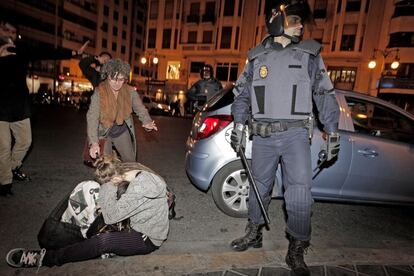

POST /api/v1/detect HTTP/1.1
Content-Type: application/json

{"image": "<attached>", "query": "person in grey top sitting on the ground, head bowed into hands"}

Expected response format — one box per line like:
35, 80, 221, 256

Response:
6, 156, 169, 268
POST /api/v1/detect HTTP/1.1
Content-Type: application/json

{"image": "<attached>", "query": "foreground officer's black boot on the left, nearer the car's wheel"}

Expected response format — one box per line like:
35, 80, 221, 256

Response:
230, 220, 263, 251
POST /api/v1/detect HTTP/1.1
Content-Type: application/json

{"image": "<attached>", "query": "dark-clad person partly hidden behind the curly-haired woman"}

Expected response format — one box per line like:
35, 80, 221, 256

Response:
79, 44, 112, 88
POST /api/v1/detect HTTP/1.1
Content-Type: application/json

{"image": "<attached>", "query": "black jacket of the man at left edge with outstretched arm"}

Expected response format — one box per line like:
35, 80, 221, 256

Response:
0, 43, 72, 122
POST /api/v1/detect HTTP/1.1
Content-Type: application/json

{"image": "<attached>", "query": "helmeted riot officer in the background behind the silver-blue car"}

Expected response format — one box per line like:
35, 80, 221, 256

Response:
186, 64, 223, 109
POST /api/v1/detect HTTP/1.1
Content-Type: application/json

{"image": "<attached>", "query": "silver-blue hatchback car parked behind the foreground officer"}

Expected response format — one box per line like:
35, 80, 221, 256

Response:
185, 89, 414, 217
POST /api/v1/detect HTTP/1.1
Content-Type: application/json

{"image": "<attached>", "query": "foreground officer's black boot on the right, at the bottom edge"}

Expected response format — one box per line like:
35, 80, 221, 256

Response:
286, 235, 310, 276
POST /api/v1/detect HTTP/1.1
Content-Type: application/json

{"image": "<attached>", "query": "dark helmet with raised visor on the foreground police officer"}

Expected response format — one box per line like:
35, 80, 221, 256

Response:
266, 0, 312, 38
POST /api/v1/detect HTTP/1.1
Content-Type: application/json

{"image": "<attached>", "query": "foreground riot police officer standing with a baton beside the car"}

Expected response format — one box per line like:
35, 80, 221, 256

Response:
231, 0, 339, 275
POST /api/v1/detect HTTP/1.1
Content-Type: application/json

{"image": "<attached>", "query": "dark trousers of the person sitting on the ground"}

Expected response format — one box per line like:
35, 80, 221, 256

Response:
42, 230, 158, 266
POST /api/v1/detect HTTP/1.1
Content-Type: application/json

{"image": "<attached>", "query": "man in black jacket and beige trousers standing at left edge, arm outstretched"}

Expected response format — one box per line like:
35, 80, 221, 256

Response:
0, 15, 86, 196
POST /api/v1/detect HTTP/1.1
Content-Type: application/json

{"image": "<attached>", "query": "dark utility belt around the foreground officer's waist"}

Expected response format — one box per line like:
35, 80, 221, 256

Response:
250, 120, 313, 138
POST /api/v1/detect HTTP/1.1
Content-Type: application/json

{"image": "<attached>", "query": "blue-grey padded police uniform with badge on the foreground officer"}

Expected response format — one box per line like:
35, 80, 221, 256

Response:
232, 36, 339, 241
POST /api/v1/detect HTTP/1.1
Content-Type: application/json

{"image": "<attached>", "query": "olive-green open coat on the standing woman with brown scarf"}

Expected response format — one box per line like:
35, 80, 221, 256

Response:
86, 89, 152, 156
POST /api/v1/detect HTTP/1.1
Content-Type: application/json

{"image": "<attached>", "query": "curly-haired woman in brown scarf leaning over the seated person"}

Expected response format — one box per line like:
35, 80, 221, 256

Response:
86, 59, 158, 162
